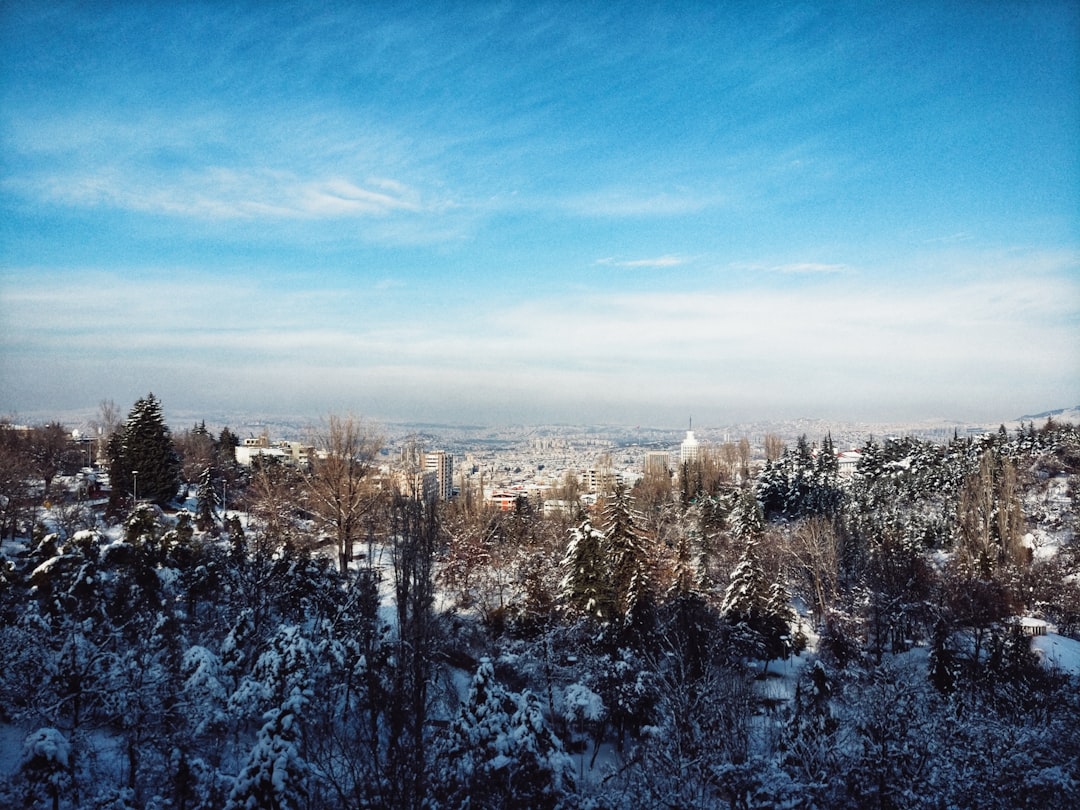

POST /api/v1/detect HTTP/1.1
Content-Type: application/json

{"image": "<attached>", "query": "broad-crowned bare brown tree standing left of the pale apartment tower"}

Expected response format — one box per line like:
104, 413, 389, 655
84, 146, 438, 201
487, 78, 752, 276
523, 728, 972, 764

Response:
305, 416, 382, 573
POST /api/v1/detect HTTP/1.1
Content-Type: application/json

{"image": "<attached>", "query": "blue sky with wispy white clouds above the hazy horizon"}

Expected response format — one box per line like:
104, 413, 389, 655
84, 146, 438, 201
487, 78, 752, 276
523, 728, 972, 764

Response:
0, 0, 1080, 427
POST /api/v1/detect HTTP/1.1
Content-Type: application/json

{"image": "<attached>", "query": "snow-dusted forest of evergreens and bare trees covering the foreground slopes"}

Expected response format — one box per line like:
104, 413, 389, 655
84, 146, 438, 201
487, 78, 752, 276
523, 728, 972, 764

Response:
0, 394, 1080, 810
